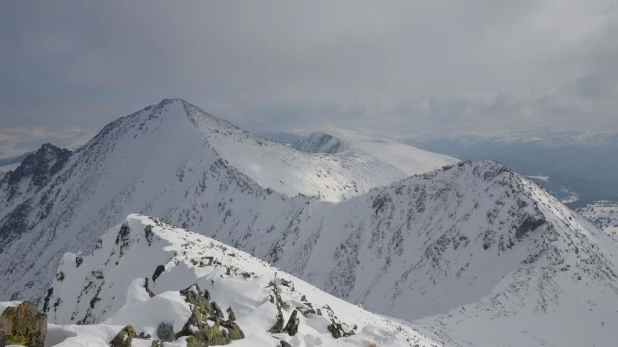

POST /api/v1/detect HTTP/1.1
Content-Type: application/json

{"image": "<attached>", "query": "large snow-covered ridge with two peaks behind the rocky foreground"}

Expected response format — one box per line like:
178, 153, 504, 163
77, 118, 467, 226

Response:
0, 100, 618, 346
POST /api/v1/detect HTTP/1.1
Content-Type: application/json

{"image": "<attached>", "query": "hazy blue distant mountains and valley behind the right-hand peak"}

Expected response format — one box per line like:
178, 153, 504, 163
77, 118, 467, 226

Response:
407, 131, 618, 208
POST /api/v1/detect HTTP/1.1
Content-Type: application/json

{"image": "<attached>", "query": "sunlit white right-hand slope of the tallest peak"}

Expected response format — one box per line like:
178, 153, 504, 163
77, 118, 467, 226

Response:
180, 100, 416, 202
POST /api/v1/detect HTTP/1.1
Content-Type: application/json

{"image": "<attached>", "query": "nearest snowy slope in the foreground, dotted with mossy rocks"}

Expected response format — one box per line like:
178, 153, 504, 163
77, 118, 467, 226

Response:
36, 215, 438, 347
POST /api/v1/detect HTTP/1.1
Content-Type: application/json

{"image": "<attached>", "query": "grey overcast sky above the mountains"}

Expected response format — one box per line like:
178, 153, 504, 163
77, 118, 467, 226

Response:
0, 0, 618, 137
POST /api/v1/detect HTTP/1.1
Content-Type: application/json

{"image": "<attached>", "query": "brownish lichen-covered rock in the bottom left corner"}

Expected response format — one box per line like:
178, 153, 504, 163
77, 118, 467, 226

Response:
0, 301, 47, 347
